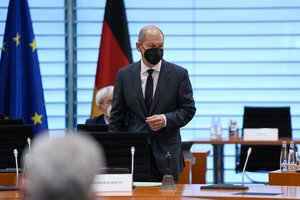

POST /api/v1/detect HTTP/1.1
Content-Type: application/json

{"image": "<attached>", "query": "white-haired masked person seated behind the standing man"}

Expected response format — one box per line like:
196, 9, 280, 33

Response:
85, 86, 114, 124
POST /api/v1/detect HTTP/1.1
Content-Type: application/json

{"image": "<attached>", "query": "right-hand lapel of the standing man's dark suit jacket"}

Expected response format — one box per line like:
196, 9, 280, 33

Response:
150, 60, 171, 114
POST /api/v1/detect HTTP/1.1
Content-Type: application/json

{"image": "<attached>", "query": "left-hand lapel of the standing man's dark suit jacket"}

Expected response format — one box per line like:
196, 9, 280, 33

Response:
130, 62, 147, 113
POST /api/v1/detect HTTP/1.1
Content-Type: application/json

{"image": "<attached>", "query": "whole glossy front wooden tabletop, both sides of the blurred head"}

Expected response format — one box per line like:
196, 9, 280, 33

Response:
0, 184, 300, 200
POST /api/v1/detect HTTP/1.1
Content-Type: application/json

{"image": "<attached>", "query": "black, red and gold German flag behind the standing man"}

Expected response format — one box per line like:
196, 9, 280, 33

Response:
91, 0, 132, 117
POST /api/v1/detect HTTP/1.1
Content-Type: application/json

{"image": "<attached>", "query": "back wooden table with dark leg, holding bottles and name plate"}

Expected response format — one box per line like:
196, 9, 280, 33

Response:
190, 137, 300, 183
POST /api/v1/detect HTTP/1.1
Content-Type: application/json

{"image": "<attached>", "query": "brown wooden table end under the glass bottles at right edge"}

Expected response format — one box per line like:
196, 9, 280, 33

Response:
269, 170, 300, 186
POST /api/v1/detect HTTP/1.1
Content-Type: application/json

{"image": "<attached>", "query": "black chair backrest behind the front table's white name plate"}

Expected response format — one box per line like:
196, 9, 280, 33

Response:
79, 130, 151, 182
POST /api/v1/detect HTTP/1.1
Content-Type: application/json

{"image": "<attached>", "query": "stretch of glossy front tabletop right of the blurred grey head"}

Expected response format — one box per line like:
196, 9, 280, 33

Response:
86, 184, 300, 200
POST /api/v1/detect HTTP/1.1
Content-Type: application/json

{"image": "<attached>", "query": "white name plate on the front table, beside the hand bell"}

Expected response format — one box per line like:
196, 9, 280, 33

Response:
91, 174, 132, 192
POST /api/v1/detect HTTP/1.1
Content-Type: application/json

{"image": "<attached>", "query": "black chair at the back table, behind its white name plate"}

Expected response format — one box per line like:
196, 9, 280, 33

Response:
236, 107, 292, 171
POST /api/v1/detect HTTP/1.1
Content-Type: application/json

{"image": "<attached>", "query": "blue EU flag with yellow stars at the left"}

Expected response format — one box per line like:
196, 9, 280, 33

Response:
0, 0, 48, 135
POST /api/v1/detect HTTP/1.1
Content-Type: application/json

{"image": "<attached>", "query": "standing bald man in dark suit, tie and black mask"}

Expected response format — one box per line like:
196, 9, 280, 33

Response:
109, 25, 196, 181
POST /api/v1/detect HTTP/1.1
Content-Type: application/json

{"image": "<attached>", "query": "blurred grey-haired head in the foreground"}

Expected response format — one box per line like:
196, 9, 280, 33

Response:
22, 133, 105, 200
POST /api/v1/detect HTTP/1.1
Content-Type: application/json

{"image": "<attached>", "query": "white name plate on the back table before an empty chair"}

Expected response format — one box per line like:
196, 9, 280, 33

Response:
243, 128, 278, 141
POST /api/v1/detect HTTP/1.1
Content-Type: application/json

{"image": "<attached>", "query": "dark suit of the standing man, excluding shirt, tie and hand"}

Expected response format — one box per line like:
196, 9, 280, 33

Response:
109, 60, 196, 177
